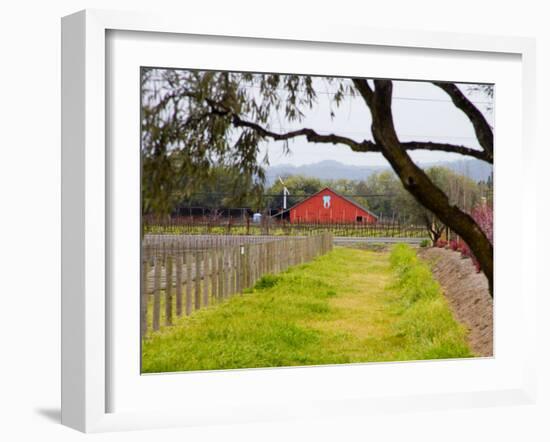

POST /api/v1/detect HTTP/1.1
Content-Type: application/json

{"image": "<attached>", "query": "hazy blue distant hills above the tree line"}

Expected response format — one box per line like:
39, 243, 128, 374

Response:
266, 159, 493, 185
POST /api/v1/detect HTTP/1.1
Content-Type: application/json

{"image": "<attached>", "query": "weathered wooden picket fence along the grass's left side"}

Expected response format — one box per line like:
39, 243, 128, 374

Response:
141, 233, 332, 338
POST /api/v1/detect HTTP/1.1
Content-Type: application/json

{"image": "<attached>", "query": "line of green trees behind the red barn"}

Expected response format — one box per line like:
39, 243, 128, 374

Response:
167, 166, 493, 241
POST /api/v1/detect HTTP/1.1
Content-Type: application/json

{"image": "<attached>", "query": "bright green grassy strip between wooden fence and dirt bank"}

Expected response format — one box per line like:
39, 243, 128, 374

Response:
142, 246, 472, 373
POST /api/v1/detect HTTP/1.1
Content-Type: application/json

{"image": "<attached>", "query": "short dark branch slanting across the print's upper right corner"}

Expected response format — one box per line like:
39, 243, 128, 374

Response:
433, 81, 493, 163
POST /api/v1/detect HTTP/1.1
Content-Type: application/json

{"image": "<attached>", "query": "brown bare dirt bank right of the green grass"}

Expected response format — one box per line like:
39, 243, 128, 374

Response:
418, 248, 493, 356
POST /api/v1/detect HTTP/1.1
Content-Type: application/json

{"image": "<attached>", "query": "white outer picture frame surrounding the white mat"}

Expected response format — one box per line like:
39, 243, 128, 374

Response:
62, 10, 536, 432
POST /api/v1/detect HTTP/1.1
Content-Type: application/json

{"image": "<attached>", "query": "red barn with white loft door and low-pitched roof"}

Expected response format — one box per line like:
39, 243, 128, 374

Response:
289, 187, 377, 224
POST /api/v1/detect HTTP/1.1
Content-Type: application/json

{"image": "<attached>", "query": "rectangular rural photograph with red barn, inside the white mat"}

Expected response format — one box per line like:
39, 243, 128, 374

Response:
135, 66, 496, 374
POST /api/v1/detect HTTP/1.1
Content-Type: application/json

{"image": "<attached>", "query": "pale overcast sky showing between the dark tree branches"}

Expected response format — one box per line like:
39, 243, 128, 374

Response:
261, 81, 494, 166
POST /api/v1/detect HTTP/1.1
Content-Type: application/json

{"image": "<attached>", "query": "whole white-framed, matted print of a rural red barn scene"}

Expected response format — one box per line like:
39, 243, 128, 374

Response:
62, 11, 536, 431
